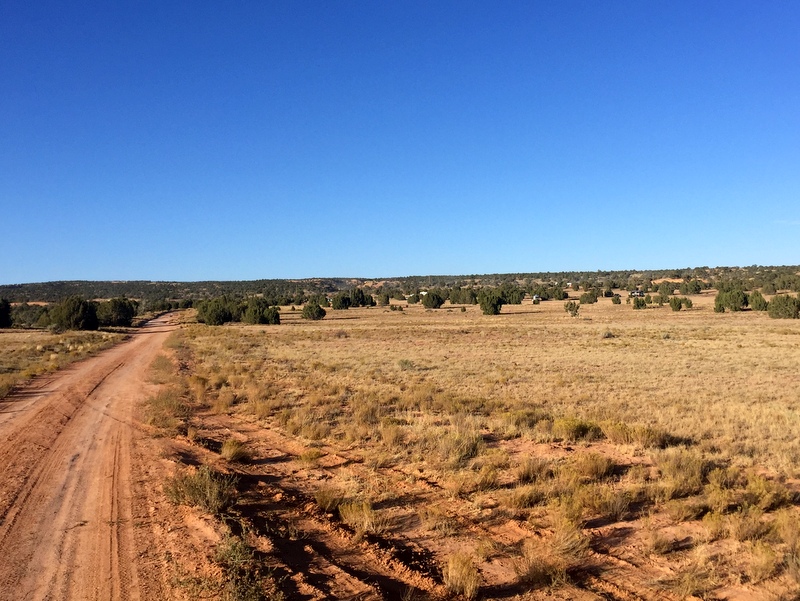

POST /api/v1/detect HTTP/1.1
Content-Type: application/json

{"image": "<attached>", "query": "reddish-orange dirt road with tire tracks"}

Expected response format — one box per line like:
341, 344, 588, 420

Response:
0, 317, 175, 601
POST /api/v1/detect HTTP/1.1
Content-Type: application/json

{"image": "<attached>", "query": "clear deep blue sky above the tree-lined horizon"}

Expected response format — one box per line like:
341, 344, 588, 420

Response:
0, 0, 800, 284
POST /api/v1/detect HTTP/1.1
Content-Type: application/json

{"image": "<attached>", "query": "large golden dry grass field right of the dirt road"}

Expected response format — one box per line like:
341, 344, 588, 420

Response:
142, 293, 800, 599
